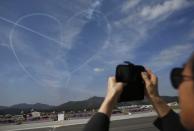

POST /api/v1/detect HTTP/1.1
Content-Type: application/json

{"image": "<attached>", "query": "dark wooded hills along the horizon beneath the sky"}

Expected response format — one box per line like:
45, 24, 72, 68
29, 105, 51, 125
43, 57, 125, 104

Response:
0, 96, 178, 115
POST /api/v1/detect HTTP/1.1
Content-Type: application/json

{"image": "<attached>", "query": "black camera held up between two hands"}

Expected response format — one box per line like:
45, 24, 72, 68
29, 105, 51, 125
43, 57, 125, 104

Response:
116, 62, 145, 102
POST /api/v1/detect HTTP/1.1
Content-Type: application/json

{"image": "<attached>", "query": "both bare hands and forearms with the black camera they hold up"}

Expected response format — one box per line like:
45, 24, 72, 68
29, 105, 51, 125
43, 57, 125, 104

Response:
99, 62, 168, 117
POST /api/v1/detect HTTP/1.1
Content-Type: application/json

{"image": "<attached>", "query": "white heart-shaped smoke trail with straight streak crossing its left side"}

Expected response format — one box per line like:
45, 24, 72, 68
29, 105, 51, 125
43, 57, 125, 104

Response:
0, 10, 111, 87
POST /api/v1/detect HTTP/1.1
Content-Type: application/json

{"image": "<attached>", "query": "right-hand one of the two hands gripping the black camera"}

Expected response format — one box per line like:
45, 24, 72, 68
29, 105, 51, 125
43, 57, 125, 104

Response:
141, 70, 159, 99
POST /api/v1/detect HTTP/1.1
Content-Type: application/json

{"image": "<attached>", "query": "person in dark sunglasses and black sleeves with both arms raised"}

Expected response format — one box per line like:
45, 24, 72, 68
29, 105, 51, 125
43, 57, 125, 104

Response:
84, 52, 194, 131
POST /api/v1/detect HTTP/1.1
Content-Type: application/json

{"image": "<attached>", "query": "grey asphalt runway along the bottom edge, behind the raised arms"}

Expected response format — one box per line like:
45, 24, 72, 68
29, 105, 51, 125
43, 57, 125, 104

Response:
2, 116, 158, 131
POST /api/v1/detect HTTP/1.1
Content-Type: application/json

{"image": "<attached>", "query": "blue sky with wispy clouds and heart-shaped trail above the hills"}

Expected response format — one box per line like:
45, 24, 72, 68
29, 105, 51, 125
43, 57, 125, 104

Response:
0, 0, 194, 105
